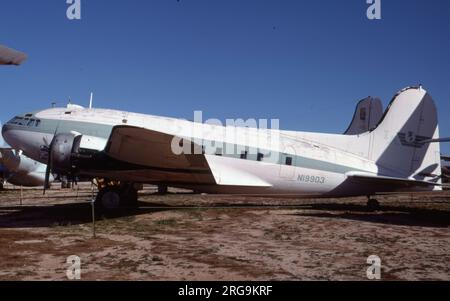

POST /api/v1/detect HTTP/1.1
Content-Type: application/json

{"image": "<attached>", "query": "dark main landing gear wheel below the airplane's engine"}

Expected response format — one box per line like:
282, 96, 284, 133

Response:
95, 179, 141, 210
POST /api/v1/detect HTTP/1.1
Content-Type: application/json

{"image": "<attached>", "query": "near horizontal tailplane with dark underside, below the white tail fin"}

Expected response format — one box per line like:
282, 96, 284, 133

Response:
346, 171, 442, 187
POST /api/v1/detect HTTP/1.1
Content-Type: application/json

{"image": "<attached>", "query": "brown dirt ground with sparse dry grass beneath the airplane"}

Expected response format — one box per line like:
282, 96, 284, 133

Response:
0, 185, 450, 280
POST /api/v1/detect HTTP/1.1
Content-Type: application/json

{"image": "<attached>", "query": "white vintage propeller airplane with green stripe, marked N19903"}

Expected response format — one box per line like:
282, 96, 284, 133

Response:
2, 87, 444, 208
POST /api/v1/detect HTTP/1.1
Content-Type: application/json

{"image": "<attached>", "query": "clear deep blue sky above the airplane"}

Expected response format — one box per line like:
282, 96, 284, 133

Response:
0, 0, 450, 153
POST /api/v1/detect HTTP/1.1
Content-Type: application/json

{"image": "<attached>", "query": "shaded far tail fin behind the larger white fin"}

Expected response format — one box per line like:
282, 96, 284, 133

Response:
344, 96, 383, 135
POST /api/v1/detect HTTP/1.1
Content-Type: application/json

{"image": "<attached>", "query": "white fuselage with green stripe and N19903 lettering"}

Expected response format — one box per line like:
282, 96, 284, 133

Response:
3, 107, 434, 196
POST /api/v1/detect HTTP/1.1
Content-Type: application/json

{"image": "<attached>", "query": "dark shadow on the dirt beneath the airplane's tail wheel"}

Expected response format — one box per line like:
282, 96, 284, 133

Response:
293, 204, 450, 228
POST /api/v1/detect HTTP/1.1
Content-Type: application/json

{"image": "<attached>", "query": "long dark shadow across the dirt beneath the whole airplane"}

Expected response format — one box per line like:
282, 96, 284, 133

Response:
0, 202, 450, 228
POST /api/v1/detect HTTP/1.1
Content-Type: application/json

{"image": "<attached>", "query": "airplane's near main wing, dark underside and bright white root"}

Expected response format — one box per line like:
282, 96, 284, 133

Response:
105, 126, 270, 187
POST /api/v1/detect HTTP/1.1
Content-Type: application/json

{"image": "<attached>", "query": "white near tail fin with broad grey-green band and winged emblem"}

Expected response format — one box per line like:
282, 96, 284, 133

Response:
370, 87, 441, 182
